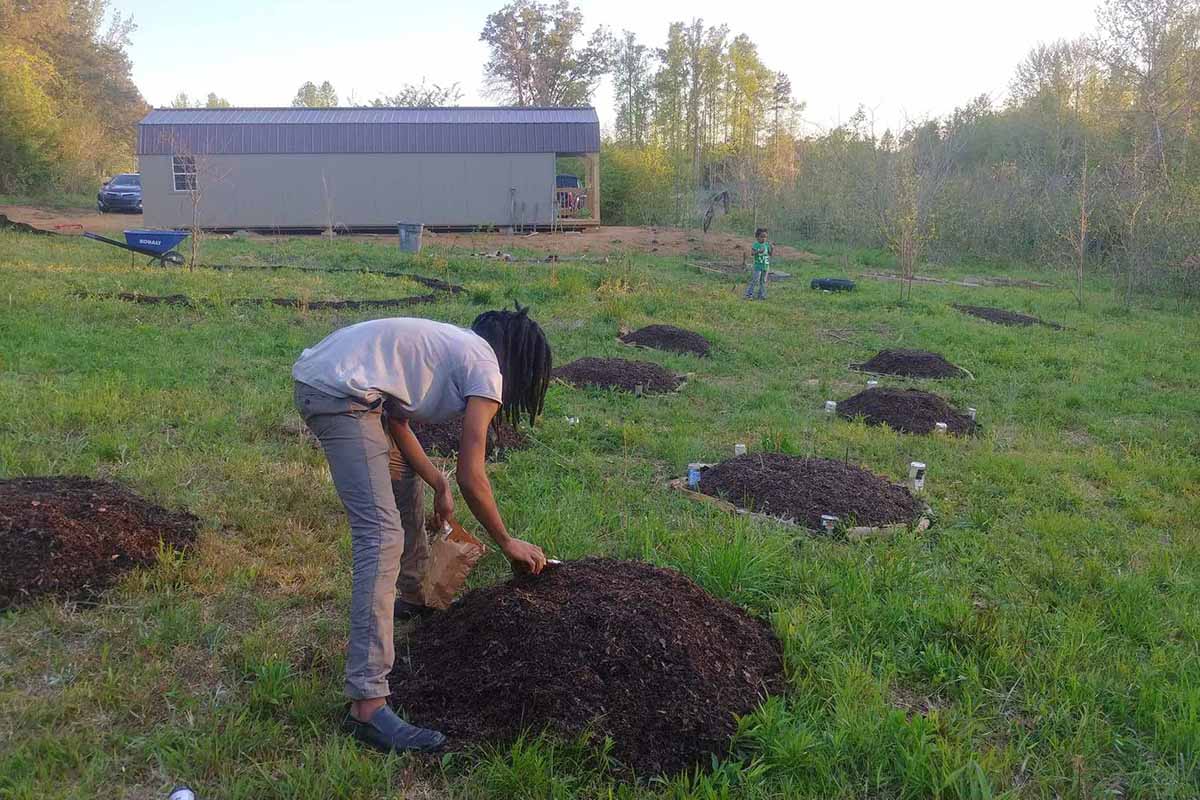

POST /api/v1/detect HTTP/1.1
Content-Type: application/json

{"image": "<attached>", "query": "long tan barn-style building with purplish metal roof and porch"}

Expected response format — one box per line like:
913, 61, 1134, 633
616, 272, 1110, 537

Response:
137, 108, 600, 230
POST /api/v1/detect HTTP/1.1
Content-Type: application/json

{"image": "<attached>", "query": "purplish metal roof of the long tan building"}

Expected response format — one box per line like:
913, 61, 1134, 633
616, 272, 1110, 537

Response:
138, 107, 600, 155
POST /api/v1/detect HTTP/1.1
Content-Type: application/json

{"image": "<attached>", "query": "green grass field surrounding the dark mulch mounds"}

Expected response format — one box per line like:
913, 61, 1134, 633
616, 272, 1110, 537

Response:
0, 233, 1200, 800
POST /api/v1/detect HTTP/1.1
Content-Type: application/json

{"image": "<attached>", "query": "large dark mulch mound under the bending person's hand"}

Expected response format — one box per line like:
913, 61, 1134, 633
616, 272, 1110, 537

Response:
391, 558, 785, 776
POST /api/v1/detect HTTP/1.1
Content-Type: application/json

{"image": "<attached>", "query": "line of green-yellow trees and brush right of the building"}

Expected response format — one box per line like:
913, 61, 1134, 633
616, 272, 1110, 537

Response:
588, 0, 1200, 303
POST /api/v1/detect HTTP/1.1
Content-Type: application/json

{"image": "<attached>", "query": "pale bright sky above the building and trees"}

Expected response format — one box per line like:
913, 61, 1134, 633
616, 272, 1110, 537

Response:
113, 0, 1098, 130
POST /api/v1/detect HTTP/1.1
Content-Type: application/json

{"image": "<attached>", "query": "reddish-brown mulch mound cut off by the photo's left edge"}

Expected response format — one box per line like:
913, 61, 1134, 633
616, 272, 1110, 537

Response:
0, 477, 199, 609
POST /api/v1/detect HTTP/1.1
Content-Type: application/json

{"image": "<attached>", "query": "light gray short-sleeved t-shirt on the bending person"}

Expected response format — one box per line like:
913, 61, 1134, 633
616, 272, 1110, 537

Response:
292, 317, 503, 422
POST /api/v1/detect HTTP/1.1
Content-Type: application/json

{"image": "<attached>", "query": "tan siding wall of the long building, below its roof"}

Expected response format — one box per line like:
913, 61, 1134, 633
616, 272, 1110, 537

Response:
139, 154, 554, 228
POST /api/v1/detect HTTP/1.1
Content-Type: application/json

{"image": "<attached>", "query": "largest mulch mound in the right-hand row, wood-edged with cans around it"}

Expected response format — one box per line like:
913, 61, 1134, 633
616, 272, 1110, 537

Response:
700, 453, 922, 530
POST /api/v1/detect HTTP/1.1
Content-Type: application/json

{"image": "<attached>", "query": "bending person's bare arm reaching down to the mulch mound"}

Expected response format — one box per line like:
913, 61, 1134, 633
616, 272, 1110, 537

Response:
456, 397, 546, 575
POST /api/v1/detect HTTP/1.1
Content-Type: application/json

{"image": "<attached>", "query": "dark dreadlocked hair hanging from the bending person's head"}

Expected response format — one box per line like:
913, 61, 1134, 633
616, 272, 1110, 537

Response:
470, 303, 552, 426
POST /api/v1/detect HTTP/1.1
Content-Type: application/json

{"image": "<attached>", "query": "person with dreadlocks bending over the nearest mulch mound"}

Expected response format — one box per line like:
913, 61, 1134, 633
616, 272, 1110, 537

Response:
292, 307, 551, 751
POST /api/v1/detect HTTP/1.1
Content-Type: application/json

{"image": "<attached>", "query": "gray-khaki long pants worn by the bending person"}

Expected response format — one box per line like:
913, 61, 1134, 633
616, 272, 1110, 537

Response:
295, 381, 428, 699
